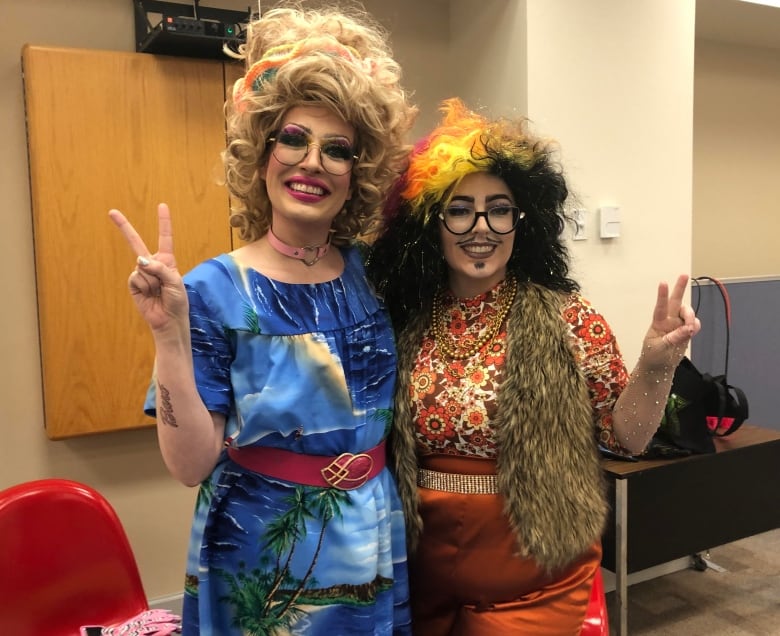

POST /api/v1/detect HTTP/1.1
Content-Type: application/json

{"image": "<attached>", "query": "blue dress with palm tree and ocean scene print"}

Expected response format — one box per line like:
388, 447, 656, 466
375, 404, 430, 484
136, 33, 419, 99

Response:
146, 249, 411, 636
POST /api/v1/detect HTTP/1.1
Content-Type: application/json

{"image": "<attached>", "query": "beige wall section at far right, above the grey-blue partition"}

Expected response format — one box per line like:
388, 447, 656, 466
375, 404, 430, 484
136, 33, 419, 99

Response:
693, 38, 780, 278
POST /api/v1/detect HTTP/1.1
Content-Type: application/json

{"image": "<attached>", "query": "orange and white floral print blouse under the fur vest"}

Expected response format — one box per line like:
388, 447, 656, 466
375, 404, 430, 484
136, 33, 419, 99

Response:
410, 282, 628, 458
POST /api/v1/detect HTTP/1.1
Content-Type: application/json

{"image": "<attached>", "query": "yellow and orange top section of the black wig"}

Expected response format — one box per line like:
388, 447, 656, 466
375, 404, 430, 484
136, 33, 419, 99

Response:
401, 97, 536, 222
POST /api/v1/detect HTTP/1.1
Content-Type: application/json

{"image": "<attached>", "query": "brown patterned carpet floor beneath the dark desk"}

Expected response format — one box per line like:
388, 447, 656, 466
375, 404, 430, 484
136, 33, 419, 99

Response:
607, 528, 780, 636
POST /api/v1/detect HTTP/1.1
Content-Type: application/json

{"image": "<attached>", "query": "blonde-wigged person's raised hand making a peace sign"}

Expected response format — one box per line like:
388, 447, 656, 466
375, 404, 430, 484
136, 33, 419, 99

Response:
108, 203, 189, 333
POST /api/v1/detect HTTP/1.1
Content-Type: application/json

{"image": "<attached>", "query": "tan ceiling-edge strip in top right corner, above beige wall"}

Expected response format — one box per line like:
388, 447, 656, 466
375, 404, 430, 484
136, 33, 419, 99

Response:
696, 0, 780, 49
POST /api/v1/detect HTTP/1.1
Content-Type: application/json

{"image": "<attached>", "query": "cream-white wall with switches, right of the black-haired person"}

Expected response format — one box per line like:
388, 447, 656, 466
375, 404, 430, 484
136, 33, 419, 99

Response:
528, 0, 695, 368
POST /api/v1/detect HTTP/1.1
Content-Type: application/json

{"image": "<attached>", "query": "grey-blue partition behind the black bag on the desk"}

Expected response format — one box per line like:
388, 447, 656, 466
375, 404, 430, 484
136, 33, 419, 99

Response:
691, 278, 780, 430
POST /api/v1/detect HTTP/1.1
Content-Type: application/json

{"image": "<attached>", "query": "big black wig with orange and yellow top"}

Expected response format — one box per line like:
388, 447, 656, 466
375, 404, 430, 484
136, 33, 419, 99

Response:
366, 99, 579, 330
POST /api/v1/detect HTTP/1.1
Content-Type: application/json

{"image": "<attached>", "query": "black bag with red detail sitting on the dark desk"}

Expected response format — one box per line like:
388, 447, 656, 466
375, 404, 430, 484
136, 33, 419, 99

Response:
648, 276, 748, 456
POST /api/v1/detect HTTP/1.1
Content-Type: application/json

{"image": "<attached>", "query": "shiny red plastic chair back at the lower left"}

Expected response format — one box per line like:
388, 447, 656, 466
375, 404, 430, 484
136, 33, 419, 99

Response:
0, 479, 149, 636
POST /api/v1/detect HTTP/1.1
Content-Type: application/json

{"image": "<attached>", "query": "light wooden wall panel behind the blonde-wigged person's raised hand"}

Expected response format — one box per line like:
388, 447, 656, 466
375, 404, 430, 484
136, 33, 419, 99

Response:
22, 46, 231, 439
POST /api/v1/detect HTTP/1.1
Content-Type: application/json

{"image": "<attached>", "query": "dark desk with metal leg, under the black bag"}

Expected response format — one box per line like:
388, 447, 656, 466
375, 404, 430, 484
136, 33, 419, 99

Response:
602, 424, 780, 636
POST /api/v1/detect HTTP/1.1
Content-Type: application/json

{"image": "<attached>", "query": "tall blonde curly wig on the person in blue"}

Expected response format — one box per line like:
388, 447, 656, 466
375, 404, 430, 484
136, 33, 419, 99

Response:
223, 5, 417, 245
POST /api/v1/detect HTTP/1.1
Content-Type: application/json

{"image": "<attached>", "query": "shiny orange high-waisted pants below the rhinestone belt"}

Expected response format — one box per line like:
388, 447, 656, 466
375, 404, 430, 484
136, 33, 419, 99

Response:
410, 457, 601, 636
